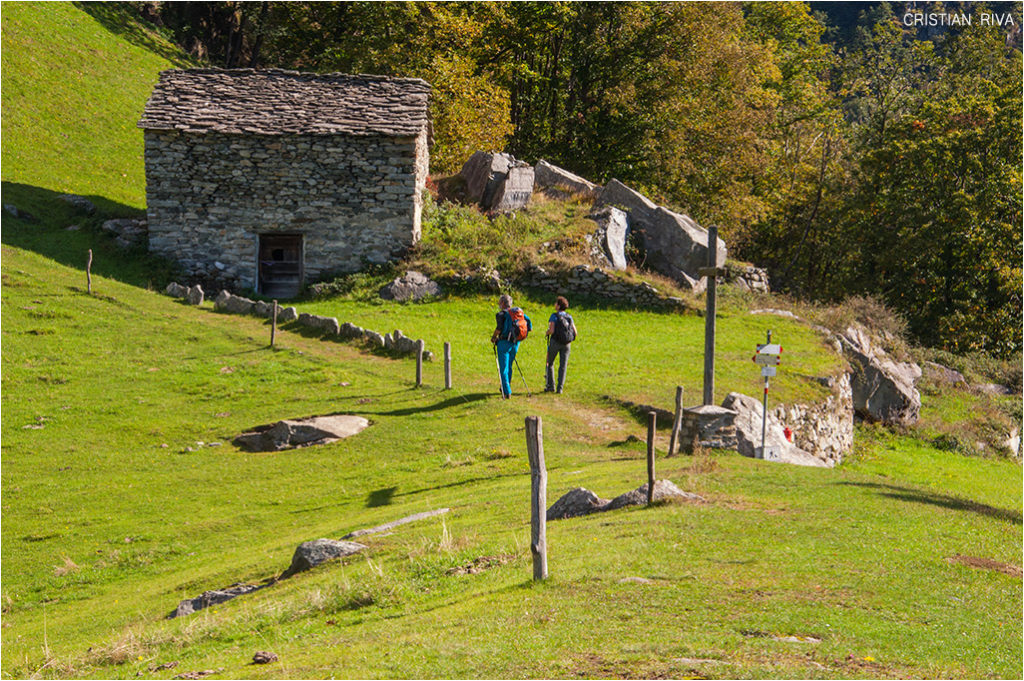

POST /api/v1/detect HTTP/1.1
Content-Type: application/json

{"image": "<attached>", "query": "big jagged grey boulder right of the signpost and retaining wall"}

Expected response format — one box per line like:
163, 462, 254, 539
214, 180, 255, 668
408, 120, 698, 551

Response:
839, 325, 921, 424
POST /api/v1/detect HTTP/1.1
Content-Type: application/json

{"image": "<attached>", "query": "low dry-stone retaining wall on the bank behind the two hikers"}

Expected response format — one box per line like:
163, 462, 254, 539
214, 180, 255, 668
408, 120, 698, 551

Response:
517, 265, 686, 309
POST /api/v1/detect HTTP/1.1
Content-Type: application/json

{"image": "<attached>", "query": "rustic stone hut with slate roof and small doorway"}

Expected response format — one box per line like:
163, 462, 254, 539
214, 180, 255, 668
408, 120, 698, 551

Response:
138, 69, 430, 298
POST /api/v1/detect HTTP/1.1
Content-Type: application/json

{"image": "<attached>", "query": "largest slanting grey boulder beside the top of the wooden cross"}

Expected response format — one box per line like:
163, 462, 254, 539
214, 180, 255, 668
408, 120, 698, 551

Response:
595, 179, 727, 291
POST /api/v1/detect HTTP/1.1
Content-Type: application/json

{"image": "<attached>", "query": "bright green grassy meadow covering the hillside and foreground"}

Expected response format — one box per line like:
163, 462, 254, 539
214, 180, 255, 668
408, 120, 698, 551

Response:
0, 3, 1024, 679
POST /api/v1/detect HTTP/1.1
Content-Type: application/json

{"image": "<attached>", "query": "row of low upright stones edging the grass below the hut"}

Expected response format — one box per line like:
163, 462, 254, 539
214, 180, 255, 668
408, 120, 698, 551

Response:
165, 283, 434, 361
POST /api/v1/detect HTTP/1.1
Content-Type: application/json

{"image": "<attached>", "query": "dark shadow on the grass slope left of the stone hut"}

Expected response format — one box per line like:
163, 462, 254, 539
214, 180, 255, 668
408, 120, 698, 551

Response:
0, 182, 176, 294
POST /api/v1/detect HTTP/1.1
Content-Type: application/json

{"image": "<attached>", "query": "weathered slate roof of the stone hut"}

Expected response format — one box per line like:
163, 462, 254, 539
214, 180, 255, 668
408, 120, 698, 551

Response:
138, 69, 430, 137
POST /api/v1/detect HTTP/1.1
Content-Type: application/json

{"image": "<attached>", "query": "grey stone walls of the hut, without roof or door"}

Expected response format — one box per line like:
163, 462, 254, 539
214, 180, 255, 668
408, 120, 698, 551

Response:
145, 130, 429, 289
